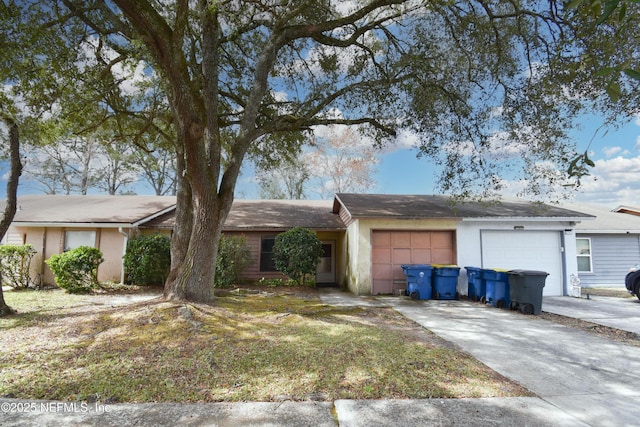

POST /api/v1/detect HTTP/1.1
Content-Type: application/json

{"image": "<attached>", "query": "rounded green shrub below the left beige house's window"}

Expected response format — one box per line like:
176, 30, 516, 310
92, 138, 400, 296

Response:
45, 246, 104, 294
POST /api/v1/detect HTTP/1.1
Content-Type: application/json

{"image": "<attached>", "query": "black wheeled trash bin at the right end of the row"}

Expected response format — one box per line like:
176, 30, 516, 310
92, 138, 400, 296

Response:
507, 270, 549, 315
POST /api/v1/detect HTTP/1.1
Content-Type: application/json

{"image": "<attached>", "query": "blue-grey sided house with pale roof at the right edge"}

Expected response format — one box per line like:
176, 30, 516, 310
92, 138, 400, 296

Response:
568, 203, 640, 287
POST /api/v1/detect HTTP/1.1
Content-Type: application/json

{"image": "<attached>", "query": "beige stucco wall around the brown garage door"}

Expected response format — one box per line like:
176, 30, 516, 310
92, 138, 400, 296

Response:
345, 219, 456, 295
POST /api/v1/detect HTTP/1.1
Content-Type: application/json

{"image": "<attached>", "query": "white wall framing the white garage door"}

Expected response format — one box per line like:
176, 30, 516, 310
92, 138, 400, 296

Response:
457, 220, 578, 295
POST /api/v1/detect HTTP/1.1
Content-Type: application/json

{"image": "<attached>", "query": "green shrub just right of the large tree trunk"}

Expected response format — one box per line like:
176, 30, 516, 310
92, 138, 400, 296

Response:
215, 235, 253, 288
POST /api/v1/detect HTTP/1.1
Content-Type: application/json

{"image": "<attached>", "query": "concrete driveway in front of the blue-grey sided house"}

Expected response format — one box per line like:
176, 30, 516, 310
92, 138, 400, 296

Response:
542, 296, 640, 334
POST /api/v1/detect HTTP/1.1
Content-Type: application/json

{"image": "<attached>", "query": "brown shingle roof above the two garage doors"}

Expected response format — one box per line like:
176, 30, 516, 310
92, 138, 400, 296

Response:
333, 193, 591, 220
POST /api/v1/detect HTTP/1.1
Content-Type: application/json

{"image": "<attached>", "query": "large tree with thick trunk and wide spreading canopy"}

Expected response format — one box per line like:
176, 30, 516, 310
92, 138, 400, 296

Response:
2, 0, 640, 301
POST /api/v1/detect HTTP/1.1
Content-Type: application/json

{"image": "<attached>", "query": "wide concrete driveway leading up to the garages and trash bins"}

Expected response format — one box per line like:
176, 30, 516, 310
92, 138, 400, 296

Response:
378, 297, 640, 426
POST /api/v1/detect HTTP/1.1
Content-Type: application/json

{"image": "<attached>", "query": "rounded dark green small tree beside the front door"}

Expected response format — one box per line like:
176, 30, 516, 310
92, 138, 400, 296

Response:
273, 227, 322, 285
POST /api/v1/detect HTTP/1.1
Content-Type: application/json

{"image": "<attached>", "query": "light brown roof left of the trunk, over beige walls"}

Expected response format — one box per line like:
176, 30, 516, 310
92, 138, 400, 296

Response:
0, 195, 176, 224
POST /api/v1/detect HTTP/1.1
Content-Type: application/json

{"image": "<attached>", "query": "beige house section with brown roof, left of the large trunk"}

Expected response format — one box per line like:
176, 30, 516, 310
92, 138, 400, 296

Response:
2, 195, 175, 284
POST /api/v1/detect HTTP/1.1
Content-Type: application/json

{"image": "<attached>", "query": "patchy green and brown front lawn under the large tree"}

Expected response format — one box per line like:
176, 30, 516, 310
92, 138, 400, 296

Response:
0, 291, 529, 402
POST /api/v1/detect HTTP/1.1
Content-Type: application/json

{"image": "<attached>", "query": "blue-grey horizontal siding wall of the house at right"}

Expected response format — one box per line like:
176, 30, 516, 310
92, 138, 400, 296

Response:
577, 233, 640, 287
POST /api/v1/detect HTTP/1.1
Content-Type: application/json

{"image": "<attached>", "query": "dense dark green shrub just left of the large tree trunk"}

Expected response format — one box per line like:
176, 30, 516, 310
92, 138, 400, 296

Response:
124, 234, 171, 285
